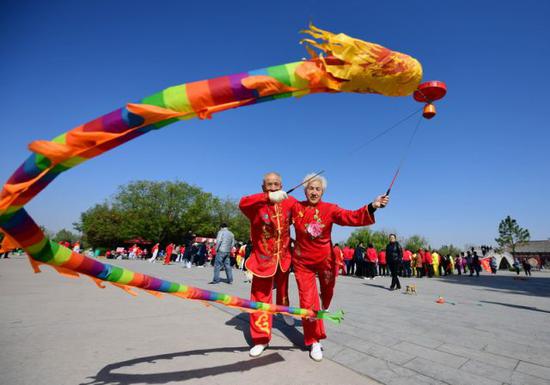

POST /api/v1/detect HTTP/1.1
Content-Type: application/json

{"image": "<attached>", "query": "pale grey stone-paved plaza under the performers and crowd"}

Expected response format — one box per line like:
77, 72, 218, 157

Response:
0, 256, 550, 385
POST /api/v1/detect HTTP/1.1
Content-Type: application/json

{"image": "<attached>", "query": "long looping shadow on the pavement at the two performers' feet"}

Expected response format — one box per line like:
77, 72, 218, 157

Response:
80, 346, 294, 385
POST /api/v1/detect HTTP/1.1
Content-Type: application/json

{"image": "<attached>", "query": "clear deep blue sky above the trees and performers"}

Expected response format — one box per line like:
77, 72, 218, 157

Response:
0, 0, 550, 246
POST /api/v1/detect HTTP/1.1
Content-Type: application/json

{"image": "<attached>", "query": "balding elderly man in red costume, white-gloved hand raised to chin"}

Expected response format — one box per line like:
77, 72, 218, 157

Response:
239, 172, 296, 357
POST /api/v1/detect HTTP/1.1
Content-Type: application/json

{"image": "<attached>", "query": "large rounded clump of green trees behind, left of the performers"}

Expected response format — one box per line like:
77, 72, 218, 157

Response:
75, 181, 249, 247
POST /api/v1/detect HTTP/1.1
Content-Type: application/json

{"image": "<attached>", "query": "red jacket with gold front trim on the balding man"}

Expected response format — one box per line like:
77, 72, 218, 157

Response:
239, 193, 296, 277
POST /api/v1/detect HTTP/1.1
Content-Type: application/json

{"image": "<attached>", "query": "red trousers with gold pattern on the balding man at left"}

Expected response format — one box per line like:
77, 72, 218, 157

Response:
250, 267, 289, 345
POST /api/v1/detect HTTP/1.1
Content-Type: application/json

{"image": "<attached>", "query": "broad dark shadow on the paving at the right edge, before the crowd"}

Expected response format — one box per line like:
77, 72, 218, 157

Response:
435, 275, 550, 297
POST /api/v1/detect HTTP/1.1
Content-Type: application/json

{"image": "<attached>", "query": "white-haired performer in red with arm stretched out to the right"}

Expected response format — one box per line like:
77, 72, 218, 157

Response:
292, 174, 389, 361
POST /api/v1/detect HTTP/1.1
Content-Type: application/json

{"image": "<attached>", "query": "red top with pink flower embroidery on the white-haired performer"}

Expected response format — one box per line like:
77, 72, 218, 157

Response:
292, 201, 374, 265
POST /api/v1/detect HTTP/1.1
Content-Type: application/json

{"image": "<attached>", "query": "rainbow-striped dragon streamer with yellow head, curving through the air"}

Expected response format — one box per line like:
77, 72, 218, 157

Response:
0, 26, 422, 322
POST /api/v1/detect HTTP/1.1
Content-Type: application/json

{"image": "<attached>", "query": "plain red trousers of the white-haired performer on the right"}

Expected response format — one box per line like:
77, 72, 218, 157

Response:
294, 262, 336, 346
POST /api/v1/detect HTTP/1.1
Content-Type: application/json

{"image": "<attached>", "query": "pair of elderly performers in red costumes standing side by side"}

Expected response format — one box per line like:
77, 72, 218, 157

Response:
239, 172, 389, 361
